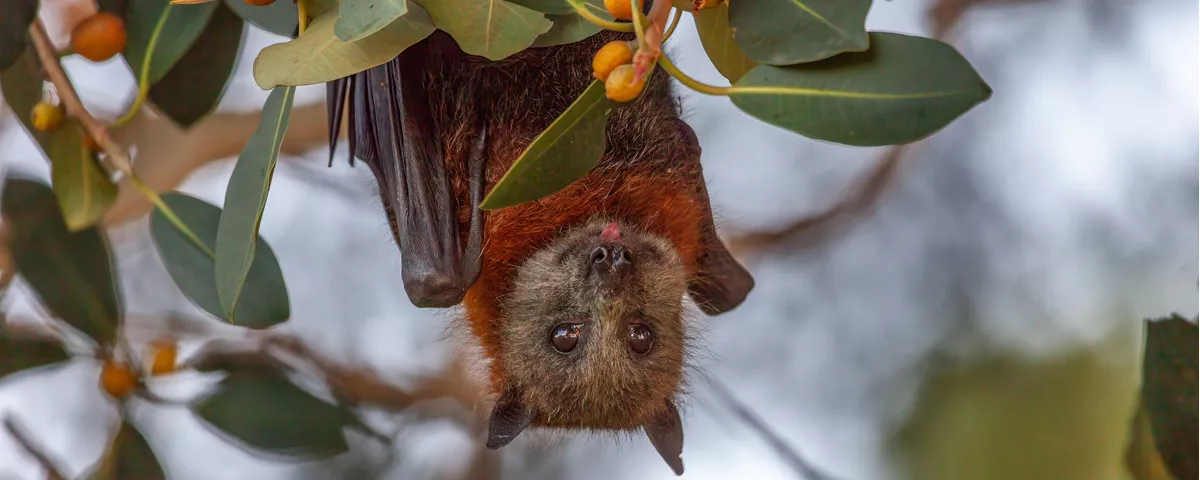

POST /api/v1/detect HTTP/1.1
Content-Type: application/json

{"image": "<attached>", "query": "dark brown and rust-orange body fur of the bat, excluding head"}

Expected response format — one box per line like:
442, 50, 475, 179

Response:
425, 31, 706, 390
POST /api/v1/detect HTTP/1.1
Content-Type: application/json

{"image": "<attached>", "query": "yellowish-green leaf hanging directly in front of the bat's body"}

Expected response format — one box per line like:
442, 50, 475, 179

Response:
480, 80, 613, 210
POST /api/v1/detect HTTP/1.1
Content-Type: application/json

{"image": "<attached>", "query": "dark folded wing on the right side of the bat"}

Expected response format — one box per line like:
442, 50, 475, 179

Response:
679, 120, 754, 316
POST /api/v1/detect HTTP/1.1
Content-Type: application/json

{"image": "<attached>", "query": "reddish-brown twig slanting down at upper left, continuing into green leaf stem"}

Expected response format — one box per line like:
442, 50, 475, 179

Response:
29, 19, 211, 254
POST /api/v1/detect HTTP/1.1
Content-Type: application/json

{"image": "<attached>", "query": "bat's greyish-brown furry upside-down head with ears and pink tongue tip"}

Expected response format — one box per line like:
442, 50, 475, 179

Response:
488, 221, 688, 472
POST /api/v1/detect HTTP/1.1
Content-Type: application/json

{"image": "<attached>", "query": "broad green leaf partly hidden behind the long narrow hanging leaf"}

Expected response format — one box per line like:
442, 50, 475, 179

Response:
150, 192, 292, 329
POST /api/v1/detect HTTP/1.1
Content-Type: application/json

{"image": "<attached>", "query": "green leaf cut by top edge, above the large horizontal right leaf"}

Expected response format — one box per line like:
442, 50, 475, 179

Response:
730, 0, 871, 65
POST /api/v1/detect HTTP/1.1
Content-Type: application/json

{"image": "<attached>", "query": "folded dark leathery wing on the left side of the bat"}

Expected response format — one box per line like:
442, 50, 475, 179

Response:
336, 40, 486, 307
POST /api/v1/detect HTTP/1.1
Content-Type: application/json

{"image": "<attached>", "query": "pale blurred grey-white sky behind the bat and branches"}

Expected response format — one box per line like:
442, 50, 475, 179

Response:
0, 0, 1200, 480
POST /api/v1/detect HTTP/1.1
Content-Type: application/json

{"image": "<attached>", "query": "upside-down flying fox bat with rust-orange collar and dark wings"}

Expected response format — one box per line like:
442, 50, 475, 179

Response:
326, 31, 754, 474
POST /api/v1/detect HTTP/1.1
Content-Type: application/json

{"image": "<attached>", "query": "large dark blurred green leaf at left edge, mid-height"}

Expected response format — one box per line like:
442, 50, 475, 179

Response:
0, 179, 121, 344
